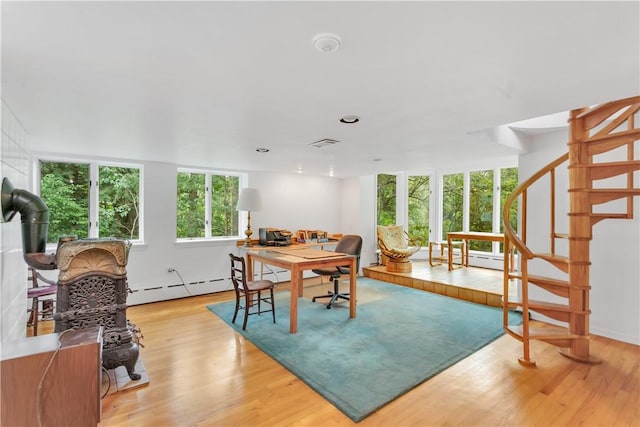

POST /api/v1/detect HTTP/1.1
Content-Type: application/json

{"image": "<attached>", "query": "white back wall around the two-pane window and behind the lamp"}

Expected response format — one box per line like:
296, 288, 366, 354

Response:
119, 162, 343, 305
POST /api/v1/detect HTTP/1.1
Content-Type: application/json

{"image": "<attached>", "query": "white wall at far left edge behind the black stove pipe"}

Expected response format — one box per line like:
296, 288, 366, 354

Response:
0, 100, 29, 341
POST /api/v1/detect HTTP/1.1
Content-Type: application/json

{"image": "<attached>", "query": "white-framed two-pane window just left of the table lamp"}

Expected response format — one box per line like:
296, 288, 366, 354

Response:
176, 170, 240, 239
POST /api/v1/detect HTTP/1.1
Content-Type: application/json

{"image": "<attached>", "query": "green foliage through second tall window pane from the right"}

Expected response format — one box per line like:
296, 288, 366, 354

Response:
469, 170, 493, 252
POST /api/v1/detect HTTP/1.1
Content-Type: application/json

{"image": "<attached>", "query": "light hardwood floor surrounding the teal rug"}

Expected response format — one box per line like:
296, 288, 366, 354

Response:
33, 283, 640, 427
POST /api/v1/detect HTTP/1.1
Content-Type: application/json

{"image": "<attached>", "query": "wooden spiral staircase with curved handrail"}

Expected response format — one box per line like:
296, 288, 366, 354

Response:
503, 96, 640, 366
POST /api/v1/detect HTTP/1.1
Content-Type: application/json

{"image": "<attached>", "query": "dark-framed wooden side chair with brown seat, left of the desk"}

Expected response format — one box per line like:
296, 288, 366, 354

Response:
229, 254, 276, 330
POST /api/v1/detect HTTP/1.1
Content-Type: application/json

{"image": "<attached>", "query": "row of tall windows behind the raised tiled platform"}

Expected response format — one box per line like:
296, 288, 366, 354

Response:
377, 167, 518, 254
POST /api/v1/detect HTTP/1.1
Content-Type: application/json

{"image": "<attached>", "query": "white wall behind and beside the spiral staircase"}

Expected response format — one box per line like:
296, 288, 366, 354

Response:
518, 131, 640, 344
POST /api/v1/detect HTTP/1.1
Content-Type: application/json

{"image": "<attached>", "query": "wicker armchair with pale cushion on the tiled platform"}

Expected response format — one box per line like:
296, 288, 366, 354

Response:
378, 225, 422, 273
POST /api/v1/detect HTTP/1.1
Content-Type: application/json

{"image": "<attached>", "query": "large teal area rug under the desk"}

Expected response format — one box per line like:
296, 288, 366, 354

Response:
207, 277, 521, 422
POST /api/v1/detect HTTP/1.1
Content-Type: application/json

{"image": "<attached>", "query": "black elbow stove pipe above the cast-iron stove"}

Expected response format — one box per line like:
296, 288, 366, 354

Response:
0, 178, 56, 270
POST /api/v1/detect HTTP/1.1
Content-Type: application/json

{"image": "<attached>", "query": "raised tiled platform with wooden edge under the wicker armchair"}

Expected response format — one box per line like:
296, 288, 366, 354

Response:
362, 262, 516, 307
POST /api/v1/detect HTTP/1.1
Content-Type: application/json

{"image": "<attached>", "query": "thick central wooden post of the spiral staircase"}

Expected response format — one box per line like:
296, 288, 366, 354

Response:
561, 109, 592, 362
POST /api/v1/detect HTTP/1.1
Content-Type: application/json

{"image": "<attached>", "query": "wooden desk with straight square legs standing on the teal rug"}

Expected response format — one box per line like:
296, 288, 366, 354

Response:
246, 248, 358, 334
